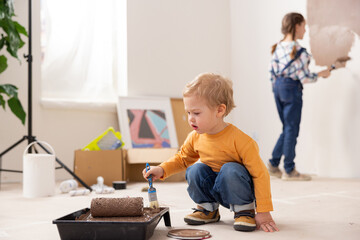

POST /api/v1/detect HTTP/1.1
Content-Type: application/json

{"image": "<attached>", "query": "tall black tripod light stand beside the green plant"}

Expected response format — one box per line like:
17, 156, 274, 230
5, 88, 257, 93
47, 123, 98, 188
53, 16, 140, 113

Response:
0, 0, 92, 191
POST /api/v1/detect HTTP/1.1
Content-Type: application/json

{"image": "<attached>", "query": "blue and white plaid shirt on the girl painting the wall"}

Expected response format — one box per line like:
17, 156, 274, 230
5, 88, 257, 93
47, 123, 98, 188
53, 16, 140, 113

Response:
270, 41, 317, 84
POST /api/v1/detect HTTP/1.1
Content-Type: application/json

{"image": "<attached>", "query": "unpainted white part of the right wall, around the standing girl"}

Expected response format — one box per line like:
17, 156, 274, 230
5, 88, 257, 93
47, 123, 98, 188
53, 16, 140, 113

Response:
230, 0, 360, 177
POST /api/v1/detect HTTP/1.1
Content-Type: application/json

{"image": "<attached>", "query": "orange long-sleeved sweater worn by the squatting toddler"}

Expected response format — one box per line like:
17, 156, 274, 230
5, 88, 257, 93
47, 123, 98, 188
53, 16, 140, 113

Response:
160, 124, 273, 212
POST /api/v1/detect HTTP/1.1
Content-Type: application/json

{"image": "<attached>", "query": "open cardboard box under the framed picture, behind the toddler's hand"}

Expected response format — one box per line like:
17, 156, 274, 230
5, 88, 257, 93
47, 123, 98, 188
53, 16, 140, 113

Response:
125, 148, 185, 182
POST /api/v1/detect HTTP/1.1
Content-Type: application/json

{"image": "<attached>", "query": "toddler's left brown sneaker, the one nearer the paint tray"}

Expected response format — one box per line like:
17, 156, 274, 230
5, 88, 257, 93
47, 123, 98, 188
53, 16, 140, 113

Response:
184, 206, 220, 225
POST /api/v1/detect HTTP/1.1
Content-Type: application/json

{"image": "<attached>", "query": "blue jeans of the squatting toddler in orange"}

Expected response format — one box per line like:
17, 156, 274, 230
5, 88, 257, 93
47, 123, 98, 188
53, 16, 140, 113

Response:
186, 162, 255, 212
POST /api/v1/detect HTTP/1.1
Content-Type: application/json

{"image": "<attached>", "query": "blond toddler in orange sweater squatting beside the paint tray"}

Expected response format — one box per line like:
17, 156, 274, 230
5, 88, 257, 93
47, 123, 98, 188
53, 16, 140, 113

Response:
143, 73, 278, 232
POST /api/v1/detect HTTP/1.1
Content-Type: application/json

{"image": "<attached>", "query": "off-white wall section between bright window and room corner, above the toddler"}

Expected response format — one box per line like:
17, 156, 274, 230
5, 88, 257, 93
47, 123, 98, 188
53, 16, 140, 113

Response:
128, 0, 230, 97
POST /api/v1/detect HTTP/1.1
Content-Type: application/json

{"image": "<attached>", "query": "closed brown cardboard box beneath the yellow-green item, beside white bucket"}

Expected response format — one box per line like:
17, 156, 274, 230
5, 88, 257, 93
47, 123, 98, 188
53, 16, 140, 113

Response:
74, 149, 126, 187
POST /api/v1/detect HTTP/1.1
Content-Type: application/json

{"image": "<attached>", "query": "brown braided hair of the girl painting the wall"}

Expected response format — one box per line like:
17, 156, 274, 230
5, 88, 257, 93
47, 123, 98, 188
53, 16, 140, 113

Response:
271, 12, 305, 59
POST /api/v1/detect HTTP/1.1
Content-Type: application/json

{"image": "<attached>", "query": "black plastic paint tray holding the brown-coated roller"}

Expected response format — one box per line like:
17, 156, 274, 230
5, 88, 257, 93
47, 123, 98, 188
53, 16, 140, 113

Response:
53, 208, 171, 240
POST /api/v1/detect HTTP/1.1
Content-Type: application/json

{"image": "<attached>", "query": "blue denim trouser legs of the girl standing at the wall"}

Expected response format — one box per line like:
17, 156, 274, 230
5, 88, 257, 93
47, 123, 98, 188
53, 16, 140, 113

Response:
270, 77, 303, 173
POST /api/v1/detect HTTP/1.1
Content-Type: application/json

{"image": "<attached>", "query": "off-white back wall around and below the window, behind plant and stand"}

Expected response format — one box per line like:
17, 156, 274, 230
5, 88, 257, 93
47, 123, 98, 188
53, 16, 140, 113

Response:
0, 0, 230, 182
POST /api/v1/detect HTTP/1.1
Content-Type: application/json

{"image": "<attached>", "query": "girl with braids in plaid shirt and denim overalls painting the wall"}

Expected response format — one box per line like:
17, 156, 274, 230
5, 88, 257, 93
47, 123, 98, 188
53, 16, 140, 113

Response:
268, 13, 330, 181
